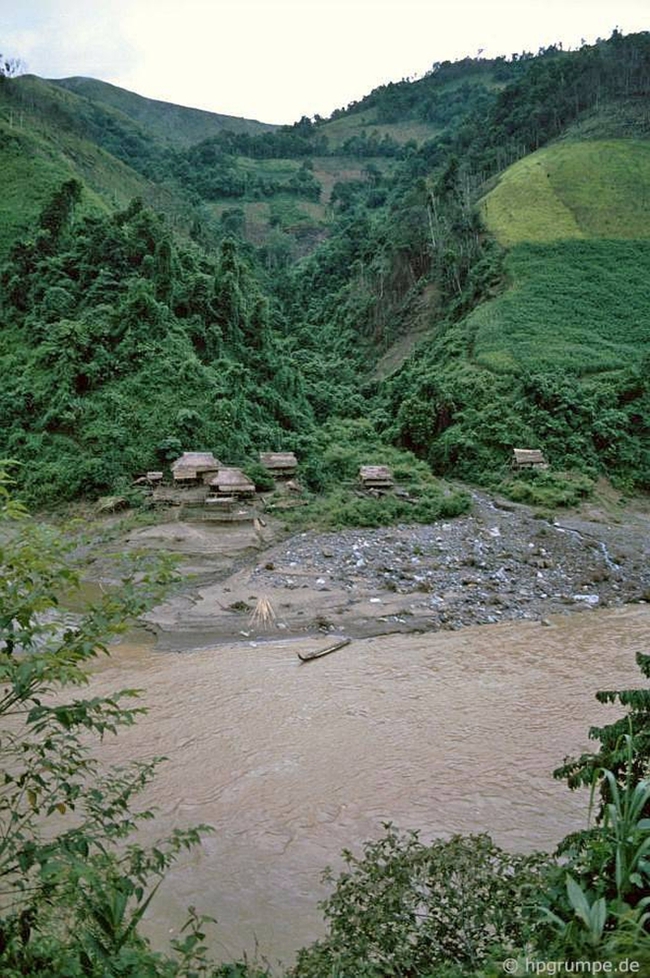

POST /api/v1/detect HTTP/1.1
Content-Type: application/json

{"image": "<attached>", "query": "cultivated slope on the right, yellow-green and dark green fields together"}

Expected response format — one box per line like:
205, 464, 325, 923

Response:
468, 139, 650, 376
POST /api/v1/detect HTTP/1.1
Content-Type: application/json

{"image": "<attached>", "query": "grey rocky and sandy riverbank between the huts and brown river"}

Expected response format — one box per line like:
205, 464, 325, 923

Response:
126, 492, 650, 650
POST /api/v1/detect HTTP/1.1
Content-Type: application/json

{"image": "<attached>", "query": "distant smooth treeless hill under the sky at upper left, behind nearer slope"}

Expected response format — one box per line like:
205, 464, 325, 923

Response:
51, 77, 276, 146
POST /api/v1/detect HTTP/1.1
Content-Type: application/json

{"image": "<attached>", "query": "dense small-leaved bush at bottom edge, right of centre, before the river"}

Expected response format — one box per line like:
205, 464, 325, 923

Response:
291, 824, 548, 978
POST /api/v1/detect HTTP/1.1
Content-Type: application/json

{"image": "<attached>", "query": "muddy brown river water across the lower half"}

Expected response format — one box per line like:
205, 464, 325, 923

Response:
85, 605, 650, 964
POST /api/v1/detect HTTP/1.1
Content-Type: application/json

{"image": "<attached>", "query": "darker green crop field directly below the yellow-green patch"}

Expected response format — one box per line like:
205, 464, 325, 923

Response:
468, 241, 650, 376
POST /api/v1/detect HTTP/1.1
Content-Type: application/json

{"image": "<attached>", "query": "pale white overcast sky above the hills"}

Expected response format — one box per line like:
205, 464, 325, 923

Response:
0, 0, 650, 123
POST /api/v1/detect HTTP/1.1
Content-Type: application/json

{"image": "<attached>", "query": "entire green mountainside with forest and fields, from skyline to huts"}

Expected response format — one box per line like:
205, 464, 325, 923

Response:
0, 32, 650, 502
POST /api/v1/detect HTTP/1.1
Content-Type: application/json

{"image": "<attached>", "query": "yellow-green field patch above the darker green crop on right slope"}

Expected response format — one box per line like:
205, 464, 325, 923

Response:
481, 139, 650, 247
